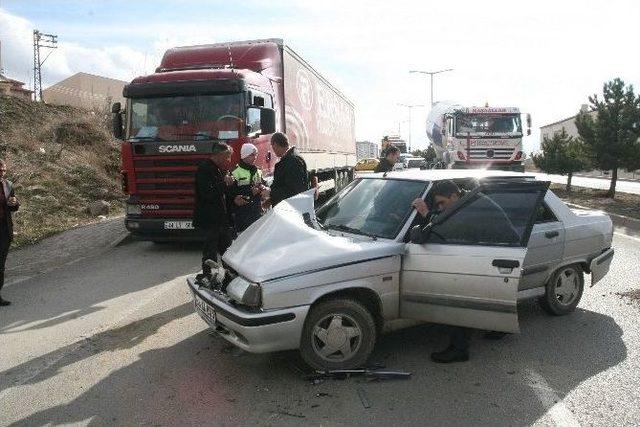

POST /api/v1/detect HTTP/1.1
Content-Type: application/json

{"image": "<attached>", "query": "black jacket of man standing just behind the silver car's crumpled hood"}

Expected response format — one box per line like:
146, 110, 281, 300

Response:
271, 147, 309, 206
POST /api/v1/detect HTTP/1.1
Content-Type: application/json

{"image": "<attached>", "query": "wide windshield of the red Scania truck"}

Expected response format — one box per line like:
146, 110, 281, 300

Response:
128, 93, 244, 141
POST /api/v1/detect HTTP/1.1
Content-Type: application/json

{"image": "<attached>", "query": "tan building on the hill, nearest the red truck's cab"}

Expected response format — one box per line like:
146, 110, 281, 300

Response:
42, 73, 127, 112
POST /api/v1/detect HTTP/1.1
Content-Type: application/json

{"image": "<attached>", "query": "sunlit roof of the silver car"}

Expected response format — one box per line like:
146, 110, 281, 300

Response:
358, 169, 535, 181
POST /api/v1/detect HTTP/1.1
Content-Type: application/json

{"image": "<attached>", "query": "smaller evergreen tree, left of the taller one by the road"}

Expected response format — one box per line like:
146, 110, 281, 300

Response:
533, 128, 589, 191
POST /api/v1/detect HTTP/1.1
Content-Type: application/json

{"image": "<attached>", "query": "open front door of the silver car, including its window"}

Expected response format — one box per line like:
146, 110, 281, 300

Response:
400, 180, 549, 332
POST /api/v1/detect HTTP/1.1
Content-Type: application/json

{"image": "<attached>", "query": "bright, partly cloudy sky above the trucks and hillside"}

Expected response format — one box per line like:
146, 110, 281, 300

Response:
0, 0, 640, 153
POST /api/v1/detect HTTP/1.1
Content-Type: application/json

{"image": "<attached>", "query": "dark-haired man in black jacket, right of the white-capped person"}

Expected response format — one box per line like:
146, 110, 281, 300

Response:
264, 132, 309, 206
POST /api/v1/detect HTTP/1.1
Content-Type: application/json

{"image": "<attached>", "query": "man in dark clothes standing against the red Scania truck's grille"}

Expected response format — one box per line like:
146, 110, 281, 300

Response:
193, 143, 234, 277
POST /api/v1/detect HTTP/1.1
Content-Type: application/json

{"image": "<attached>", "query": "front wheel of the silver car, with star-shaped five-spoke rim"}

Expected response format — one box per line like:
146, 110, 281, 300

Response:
300, 299, 376, 370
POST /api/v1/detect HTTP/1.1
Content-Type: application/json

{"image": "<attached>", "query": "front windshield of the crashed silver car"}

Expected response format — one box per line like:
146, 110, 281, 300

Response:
316, 178, 428, 239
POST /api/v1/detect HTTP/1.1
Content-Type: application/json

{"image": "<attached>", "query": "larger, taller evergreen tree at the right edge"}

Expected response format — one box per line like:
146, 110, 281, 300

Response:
576, 78, 640, 197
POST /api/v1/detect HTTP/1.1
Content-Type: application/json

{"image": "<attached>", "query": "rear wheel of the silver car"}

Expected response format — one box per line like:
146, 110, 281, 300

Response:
538, 265, 584, 316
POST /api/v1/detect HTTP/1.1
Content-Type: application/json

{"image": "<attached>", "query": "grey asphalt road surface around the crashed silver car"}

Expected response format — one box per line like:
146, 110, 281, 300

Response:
0, 235, 640, 426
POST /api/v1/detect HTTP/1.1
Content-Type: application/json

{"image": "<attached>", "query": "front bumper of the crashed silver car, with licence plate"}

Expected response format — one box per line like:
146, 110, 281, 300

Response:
187, 277, 309, 353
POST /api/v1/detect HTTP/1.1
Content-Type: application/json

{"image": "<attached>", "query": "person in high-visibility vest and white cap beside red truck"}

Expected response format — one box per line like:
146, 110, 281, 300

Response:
231, 143, 266, 234
